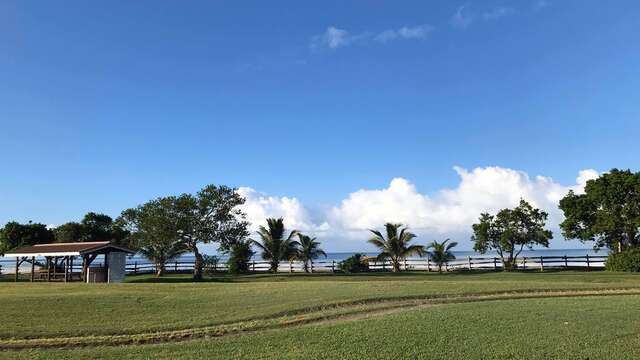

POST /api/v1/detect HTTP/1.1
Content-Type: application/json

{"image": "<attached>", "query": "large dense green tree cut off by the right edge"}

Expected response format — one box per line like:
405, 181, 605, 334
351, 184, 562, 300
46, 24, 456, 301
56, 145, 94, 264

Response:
560, 169, 640, 252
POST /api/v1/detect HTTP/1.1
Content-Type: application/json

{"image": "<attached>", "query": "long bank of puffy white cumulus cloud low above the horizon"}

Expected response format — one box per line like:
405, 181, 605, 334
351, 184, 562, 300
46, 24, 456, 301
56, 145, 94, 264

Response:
240, 167, 598, 250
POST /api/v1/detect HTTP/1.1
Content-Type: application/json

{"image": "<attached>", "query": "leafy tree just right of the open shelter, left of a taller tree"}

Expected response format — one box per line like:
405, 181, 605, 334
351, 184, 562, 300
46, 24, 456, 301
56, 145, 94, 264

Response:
119, 196, 189, 276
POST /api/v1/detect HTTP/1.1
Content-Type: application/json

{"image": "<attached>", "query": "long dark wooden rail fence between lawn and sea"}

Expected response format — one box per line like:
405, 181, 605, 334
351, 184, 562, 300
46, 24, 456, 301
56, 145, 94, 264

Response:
126, 255, 607, 274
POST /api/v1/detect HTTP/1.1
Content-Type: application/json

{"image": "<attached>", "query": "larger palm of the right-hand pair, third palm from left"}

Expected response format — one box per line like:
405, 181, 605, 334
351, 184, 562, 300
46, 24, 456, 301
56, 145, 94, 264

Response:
369, 223, 425, 272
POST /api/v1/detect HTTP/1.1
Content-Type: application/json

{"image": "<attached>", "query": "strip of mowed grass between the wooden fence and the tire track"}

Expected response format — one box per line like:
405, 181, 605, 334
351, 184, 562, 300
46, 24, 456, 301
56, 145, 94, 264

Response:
0, 272, 640, 339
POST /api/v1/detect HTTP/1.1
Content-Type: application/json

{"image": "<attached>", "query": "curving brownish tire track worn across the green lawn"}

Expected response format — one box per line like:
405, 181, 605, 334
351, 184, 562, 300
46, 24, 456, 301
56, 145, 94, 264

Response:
0, 288, 640, 350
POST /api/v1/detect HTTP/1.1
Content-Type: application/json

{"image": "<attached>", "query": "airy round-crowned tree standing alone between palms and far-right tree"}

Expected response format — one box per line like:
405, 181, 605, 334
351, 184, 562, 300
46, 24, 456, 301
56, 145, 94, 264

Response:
471, 199, 553, 270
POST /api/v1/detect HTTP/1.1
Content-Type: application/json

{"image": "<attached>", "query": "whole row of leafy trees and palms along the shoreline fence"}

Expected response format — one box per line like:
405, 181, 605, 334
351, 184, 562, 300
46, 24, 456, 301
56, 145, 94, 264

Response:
0, 169, 640, 279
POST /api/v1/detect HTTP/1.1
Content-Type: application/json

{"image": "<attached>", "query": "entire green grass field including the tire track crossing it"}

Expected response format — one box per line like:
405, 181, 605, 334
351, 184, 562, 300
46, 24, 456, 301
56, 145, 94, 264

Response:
0, 272, 640, 359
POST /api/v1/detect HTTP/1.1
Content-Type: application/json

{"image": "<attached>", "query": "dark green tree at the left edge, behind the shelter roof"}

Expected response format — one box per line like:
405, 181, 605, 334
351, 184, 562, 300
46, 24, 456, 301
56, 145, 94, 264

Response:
0, 221, 54, 254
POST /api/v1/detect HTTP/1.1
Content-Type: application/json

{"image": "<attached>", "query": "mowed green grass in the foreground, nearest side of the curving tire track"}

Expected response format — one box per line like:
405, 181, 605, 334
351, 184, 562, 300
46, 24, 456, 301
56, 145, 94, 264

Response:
12, 295, 640, 359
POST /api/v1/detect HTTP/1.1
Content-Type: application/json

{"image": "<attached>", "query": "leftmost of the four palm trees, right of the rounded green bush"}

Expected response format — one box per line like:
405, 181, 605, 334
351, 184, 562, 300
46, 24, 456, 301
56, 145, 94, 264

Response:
253, 218, 300, 273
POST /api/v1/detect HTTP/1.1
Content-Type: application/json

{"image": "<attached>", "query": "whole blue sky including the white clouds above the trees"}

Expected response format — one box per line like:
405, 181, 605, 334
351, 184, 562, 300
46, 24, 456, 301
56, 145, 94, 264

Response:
0, 0, 640, 251
